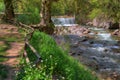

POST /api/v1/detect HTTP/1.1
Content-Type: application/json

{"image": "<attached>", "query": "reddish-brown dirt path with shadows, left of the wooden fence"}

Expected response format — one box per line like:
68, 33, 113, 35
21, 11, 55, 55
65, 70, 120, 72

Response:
0, 24, 24, 80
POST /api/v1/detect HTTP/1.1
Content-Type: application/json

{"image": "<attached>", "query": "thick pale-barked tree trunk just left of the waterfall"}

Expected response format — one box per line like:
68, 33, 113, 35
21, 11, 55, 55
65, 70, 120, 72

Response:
40, 0, 54, 34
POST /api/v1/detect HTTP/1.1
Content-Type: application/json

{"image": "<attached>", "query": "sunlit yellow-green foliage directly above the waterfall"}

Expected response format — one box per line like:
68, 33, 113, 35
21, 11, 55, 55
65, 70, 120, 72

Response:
51, 0, 75, 16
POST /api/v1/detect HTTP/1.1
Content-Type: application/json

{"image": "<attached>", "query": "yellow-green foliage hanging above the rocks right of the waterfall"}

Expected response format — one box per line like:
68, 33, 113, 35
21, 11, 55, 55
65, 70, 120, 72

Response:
74, 0, 120, 23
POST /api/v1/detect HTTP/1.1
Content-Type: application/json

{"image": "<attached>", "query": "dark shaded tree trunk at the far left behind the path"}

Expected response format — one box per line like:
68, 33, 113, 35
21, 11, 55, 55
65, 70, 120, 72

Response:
3, 0, 15, 22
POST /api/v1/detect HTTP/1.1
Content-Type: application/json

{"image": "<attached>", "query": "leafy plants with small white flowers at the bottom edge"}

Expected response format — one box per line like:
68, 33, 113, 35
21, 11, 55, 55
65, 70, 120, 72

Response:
15, 59, 50, 80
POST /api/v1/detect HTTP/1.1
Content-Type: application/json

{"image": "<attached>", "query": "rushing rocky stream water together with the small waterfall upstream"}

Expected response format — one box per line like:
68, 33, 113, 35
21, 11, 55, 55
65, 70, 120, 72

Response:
52, 18, 120, 80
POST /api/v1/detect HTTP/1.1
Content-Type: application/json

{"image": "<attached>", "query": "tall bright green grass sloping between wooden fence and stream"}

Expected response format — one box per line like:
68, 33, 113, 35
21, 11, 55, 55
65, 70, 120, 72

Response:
15, 31, 98, 80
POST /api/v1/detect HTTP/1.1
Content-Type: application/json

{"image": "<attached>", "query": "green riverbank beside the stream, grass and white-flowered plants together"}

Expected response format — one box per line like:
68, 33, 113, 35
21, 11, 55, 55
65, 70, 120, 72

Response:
16, 30, 98, 80
